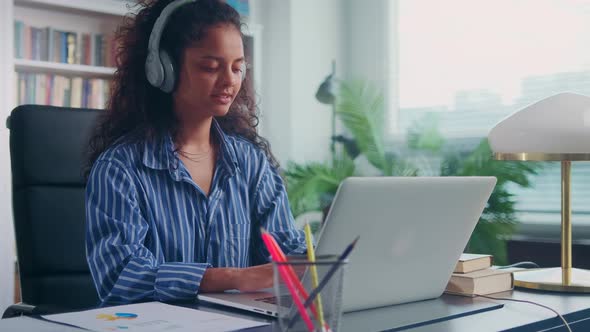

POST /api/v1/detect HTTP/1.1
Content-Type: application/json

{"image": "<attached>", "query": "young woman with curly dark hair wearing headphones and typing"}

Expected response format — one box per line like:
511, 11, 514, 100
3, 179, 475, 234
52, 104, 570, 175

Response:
86, 0, 305, 303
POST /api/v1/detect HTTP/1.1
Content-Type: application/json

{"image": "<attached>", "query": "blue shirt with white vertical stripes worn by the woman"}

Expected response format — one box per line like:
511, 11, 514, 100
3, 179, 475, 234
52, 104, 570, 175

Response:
86, 121, 305, 303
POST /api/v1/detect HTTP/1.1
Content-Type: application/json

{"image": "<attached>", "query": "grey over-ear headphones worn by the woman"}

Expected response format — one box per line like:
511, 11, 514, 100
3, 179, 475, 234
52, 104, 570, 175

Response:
145, 0, 246, 93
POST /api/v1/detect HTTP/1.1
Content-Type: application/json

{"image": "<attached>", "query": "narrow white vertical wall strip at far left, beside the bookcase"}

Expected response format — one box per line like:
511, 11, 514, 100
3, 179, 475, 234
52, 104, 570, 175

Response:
0, 1, 15, 313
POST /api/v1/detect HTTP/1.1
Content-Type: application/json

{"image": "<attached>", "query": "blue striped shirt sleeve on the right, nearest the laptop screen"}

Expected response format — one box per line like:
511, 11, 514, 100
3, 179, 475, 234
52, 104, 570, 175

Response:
254, 156, 307, 264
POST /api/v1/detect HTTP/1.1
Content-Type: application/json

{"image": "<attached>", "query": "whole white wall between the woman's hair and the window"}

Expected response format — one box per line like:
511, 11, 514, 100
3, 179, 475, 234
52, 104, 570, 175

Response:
255, 0, 398, 165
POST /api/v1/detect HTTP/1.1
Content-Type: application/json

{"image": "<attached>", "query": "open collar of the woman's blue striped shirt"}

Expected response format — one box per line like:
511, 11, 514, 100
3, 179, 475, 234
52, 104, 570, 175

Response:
143, 118, 238, 175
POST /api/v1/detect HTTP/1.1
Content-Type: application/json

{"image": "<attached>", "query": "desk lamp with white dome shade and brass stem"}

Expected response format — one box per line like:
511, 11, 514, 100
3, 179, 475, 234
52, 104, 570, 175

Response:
488, 93, 590, 293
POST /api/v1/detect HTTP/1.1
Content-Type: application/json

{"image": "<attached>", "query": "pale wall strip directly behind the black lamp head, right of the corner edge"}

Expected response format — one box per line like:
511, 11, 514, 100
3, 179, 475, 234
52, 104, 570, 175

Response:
290, 0, 343, 162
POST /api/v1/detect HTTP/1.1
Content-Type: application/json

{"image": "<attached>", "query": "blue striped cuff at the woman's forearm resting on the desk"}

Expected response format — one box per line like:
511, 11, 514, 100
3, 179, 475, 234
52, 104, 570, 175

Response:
155, 263, 211, 301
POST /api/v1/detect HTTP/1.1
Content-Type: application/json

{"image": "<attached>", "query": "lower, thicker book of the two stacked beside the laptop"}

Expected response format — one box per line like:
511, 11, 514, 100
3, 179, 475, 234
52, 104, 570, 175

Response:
445, 269, 514, 296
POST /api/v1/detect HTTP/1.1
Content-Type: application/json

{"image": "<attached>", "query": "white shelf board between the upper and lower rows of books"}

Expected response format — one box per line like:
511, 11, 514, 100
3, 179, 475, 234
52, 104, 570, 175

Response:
14, 59, 115, 78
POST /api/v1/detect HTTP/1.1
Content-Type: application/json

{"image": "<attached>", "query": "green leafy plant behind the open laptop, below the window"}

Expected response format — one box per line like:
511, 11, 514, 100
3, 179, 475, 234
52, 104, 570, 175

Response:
285, 81, 539, 264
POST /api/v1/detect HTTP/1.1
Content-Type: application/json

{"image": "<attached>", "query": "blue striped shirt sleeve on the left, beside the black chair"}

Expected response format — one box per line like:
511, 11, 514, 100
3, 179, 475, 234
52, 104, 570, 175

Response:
86, 161, 210, 303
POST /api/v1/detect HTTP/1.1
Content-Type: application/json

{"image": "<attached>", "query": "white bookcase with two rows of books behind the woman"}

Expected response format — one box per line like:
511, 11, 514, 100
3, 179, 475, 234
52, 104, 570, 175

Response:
13, 0, 127, 108
